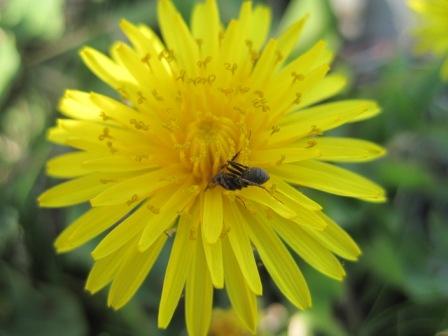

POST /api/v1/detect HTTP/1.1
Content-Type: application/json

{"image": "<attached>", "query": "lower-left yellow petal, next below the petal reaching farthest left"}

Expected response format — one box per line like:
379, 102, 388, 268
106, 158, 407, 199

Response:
54, 205, 133, 253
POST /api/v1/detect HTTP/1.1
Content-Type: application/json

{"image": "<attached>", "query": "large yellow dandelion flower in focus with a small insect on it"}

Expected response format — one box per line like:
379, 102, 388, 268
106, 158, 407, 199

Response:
39, 0, 385, 335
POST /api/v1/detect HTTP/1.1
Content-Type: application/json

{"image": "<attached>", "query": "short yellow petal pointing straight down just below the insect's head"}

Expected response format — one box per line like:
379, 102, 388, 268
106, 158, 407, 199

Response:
202, 188, 223, 244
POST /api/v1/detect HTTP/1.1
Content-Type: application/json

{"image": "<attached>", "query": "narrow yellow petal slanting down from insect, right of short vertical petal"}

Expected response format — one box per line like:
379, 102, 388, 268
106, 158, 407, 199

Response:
224, 201, 263, 295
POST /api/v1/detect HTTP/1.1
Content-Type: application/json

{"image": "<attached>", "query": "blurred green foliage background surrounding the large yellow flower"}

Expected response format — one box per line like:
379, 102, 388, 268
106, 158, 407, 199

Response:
0, 0, 448, 336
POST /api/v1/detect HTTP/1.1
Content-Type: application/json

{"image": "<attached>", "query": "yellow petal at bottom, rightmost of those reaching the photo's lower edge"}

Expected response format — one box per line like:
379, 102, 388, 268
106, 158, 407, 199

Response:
223, 239, 258, 333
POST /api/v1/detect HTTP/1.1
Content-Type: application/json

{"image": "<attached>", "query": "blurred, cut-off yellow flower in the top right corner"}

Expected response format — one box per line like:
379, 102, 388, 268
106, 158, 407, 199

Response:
408, 0, 448, 81
